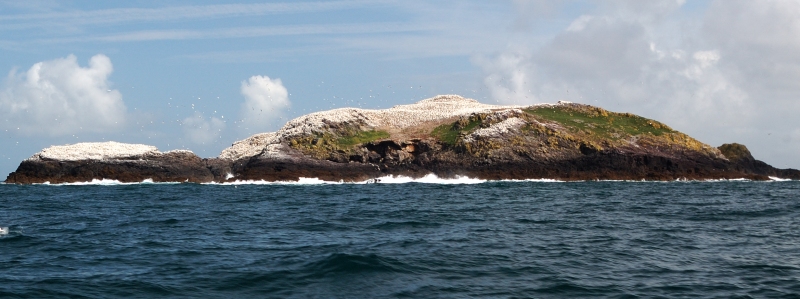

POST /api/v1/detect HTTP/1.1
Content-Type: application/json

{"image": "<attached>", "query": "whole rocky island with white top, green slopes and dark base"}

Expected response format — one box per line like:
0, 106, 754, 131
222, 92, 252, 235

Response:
6, 95, 800, 184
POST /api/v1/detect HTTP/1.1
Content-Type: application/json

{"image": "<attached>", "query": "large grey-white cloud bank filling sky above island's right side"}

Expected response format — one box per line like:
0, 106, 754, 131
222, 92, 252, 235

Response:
472, 0, 800, 167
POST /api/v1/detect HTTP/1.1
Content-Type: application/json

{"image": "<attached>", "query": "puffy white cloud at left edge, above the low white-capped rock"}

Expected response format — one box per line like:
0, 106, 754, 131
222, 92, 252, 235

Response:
0, 54, 126, 135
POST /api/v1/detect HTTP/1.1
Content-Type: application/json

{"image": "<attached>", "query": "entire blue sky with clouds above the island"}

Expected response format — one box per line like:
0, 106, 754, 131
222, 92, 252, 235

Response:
0, 0, 800, 177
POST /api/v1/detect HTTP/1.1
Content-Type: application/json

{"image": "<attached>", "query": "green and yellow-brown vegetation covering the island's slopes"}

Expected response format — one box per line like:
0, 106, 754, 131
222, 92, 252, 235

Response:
290, 104, 713, 162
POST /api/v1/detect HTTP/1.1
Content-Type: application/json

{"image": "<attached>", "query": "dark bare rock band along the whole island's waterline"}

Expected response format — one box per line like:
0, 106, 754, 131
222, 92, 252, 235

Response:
6, 139, 800, 184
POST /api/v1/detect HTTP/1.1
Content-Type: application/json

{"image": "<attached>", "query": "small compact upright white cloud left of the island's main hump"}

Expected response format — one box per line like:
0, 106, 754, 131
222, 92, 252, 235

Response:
241, 76, 291, 130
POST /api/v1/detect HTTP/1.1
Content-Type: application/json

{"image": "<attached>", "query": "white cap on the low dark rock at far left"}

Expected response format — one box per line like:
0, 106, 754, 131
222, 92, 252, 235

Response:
28, 141, 161, 161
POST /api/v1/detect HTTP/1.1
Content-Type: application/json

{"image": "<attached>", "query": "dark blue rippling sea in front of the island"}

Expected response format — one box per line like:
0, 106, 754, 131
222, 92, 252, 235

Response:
0, 182, 800, 298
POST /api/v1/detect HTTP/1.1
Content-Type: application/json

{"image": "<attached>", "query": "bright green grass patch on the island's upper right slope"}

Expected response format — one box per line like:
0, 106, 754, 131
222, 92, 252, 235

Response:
525, 105, 675, 139
